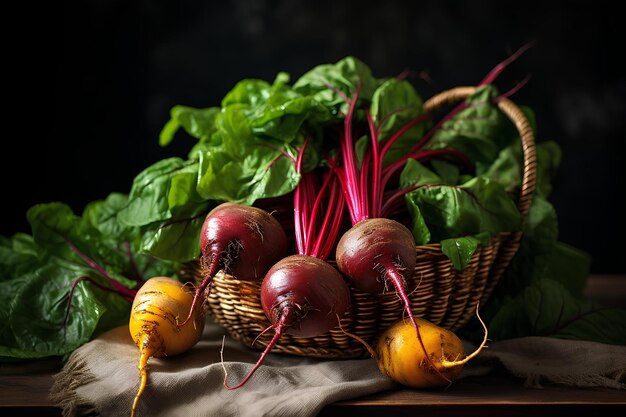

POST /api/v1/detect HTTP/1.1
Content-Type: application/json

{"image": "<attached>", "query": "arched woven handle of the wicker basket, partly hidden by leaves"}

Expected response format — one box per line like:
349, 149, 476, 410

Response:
424, 87, 537, 219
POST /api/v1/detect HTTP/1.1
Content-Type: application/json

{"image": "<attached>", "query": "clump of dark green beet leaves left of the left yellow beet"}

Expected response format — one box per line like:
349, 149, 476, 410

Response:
0, 197, 177, 360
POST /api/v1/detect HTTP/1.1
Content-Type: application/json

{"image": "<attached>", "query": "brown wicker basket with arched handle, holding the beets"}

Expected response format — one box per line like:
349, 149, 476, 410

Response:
180, 87, 536, 359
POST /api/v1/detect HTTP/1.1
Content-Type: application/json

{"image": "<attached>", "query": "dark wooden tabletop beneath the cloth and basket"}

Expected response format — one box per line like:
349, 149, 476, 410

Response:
0, 276, 626, 417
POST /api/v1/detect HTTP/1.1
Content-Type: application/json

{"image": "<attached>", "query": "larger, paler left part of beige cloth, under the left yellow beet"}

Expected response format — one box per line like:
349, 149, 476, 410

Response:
50, 320, 394, 417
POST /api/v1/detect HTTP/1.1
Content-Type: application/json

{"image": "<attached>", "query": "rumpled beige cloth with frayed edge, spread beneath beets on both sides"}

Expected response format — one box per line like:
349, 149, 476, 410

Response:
50, 316, 626, 417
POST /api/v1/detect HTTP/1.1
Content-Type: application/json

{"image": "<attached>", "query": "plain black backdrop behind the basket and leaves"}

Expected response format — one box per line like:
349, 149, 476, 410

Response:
0, 0, 626, 273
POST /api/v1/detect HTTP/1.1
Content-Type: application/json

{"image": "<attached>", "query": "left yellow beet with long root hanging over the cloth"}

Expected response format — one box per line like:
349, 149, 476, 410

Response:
128, 277, 204, 417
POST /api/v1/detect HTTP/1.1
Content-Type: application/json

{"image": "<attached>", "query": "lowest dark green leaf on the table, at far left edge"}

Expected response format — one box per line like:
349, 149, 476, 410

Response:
0, 258, 130, 358
